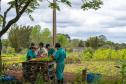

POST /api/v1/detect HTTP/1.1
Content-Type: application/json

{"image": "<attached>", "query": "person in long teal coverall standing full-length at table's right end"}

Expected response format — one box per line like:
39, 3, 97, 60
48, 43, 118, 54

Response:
53, 43, 66, 84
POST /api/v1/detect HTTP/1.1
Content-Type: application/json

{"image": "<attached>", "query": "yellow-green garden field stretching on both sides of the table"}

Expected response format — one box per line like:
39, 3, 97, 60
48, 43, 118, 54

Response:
0, 48, 126, 84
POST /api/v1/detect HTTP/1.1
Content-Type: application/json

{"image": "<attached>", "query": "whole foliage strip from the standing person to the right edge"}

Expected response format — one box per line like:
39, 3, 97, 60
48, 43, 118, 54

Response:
67, 47, 126, 62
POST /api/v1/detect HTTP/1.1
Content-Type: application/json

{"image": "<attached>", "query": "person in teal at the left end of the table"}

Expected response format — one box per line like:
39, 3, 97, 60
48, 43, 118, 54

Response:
26, 43, 37, 61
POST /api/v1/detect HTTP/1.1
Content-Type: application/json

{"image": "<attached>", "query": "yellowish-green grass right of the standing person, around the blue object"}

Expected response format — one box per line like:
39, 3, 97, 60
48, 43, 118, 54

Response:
65, 61, 121, 84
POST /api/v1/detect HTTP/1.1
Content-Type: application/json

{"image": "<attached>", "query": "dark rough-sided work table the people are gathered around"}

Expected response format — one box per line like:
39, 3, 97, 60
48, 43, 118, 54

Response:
22, 61, 55, 82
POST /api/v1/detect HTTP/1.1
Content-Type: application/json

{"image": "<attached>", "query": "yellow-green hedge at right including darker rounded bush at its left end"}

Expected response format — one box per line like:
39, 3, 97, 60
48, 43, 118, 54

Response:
82, 49, 126, 60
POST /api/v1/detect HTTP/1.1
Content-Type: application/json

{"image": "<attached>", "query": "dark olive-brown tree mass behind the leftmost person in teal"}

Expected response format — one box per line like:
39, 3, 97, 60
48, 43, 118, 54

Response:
8, 25, 32, 52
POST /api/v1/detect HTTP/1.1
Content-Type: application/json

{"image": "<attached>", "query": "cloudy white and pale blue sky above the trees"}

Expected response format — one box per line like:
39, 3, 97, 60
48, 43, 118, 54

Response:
1, 0, 126, 43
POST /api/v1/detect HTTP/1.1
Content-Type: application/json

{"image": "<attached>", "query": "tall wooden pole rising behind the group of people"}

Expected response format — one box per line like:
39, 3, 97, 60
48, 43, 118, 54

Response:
53, 0, 56, 47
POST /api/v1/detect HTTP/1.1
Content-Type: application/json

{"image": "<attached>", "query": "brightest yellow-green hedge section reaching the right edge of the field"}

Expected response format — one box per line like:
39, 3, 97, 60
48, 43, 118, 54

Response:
93, 49, 126, 60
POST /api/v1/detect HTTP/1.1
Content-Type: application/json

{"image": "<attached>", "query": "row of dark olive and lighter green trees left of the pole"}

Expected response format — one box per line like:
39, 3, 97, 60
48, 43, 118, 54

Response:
8, 25, 51, 52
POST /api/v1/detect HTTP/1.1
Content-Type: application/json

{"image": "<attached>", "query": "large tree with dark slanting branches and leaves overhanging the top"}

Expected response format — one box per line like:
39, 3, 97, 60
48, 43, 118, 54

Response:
0, 0, 102, 73
